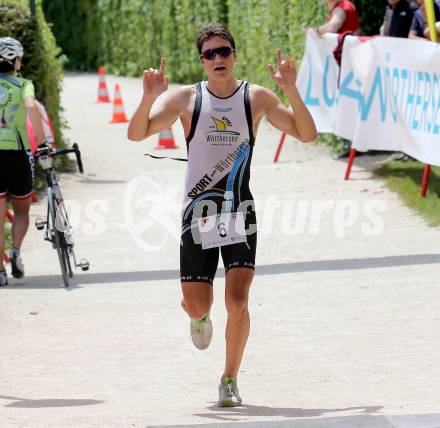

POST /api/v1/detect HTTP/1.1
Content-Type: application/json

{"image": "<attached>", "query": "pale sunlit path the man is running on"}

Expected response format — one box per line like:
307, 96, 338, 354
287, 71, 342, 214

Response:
0, 74, 440, 428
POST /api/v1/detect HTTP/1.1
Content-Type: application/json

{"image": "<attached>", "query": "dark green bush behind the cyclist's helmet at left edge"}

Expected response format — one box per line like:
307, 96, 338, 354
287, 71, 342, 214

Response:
0, 0, 63, 143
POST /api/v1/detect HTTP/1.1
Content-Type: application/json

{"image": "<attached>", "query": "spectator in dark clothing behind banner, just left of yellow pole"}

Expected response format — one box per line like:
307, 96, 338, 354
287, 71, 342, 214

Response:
380, 0, 414, 38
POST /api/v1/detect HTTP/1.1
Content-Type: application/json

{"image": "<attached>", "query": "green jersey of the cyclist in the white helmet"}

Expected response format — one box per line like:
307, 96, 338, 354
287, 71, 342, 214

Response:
0, 73, 35, 150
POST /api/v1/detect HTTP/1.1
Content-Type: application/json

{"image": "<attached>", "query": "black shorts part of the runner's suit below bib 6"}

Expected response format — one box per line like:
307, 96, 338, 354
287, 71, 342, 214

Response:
180, 213, 257, 285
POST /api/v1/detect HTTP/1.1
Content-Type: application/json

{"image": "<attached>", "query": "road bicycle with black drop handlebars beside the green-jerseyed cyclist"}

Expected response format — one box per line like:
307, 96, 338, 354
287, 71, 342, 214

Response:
34, 143, 90, 287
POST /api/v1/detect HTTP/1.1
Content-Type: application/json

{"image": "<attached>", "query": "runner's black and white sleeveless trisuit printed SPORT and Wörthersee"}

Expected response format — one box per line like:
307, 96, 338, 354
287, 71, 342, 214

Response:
180, 81, 257, 284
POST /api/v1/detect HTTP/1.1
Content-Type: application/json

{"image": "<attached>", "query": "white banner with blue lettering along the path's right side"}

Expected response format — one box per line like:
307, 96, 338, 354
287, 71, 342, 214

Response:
298, 31, 440, 165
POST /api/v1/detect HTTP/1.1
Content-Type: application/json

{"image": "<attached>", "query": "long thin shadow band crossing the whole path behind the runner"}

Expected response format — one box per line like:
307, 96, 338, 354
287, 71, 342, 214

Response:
4, 254, 440, 290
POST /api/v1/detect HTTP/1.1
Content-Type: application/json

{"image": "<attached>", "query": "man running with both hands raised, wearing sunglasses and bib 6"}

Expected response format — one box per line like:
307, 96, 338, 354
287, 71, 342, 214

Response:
128, 24, 316, 406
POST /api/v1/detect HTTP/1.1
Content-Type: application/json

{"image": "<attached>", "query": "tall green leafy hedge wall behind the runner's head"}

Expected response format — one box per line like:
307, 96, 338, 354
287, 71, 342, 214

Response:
44, 0, 327, 84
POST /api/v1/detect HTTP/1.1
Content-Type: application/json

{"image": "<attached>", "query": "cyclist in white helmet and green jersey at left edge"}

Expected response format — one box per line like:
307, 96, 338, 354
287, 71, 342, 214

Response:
0, 37, 45, 286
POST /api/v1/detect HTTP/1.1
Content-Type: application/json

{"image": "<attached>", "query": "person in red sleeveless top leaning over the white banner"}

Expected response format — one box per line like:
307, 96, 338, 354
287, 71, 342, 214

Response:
316, 0, 361, 36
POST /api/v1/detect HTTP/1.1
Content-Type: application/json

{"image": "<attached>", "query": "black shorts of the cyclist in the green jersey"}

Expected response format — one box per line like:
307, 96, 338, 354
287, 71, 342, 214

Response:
0, 150, 34, 199
